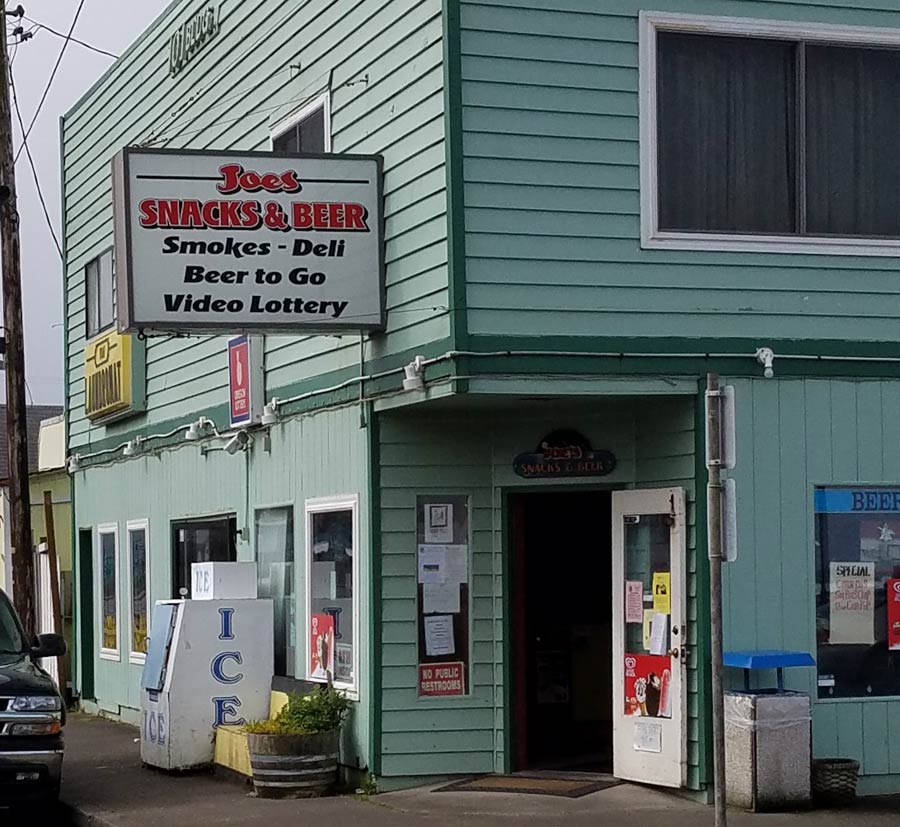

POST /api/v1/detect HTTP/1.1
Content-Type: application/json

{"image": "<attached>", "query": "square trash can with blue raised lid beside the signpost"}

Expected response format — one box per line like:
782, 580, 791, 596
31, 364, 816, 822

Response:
723, 651, 815, 812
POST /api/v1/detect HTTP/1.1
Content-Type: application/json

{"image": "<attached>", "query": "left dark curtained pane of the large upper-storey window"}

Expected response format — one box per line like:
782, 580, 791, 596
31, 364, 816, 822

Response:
657, 32, 797, 233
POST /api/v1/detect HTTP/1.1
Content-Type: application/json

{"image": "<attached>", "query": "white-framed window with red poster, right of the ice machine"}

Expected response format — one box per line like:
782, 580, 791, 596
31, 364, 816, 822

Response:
306, 497, 359, 690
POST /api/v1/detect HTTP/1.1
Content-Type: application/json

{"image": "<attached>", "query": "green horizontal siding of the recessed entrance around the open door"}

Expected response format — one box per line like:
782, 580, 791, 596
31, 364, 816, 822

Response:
376, 397, 701, 787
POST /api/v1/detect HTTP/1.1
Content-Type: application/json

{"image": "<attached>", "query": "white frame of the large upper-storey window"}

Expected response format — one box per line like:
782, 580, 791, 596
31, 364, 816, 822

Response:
639, 11, 900, 256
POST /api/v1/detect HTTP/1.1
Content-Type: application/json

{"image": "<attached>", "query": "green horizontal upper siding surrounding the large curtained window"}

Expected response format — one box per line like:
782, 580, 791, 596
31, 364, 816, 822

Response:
461, 0, 900, 341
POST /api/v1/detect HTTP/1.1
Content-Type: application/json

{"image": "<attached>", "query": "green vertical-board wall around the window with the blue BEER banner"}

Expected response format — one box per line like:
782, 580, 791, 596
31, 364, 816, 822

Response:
724, 379, 900, 776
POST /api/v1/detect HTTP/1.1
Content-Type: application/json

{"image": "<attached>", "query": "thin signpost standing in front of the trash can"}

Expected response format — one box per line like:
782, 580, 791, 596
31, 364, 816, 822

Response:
706, 373, 727, 827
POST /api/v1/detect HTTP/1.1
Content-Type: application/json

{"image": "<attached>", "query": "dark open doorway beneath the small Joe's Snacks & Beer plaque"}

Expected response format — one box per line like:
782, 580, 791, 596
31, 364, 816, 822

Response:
510, 491, 613, 772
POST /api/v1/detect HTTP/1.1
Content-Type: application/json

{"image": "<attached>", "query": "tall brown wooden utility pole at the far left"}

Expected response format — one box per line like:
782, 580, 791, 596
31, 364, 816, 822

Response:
0, 9, 35, 642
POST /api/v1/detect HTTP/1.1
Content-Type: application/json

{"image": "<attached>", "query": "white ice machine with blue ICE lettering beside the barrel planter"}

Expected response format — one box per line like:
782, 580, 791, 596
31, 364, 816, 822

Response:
141, 563, 274, 770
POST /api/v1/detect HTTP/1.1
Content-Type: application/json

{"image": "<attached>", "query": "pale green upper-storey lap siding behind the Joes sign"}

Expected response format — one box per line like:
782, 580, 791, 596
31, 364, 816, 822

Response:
62, 0, 449, 448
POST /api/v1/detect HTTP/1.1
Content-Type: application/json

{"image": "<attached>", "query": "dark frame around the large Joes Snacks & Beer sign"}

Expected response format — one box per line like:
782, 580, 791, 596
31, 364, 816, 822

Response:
112, 146, 387, 337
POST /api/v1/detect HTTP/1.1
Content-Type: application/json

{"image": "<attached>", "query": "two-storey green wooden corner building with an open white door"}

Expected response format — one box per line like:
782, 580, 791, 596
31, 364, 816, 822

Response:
67, 0, 900, 793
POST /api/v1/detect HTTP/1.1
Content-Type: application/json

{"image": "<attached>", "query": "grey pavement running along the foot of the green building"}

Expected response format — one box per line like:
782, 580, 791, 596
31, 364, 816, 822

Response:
62, 715, 900, 827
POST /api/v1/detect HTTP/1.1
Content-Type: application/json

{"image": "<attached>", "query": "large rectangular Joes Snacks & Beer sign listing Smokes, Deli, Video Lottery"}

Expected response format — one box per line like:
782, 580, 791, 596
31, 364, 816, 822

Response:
113, 148, 385, 334
